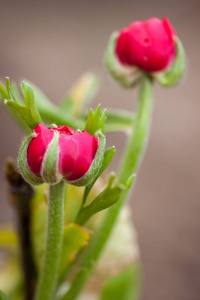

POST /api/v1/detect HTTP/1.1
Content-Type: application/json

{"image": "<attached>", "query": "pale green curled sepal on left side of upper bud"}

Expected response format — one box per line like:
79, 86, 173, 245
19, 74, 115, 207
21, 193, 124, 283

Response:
105, 32, 141, 88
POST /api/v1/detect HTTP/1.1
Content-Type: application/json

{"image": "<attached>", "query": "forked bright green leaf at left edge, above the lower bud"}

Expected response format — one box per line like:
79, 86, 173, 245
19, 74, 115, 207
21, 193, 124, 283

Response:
5, 78, 43, 129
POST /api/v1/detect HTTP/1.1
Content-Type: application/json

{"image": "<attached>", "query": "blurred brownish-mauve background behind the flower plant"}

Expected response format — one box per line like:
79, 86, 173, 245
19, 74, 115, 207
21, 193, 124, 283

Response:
0, 0, 200, 300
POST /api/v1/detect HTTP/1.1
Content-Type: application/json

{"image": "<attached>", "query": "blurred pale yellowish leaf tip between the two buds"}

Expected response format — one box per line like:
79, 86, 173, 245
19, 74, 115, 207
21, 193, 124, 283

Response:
61, 73, 98, 118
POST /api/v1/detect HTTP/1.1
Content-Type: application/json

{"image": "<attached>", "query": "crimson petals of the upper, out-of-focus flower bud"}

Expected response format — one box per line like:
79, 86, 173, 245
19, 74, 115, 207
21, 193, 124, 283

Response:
116, 18, 176, 72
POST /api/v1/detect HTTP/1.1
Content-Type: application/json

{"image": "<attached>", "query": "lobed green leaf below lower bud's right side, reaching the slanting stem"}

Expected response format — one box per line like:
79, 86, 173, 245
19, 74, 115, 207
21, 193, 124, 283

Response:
76, 174, 125, 225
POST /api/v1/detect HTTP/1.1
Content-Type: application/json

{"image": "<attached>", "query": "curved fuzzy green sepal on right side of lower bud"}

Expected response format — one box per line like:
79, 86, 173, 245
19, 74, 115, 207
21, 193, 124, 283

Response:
66, 131, 106, 186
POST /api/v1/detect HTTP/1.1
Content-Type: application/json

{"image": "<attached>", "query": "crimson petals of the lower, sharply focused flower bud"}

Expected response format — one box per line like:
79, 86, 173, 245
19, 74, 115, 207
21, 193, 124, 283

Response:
27, 124, 99, 181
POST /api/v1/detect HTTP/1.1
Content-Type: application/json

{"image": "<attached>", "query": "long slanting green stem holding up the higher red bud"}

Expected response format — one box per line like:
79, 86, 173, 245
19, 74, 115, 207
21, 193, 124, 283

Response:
62, 74, 152, 300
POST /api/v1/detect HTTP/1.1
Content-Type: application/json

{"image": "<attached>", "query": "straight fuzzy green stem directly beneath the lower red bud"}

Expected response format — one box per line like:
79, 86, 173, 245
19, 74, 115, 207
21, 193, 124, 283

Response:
35, 181, 64, 300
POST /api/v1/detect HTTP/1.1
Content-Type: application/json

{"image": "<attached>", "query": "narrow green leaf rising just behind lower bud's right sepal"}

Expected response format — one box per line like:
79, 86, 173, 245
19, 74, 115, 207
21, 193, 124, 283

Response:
82, 146, 116, 206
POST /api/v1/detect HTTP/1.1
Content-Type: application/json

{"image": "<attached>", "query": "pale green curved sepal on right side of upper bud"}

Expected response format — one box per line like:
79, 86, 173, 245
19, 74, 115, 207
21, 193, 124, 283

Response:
155, 37, 186, 87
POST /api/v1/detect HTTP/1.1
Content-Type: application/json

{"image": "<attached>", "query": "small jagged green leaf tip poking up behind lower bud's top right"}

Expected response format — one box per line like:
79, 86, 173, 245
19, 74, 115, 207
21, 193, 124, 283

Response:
85, 105, 106, 135
